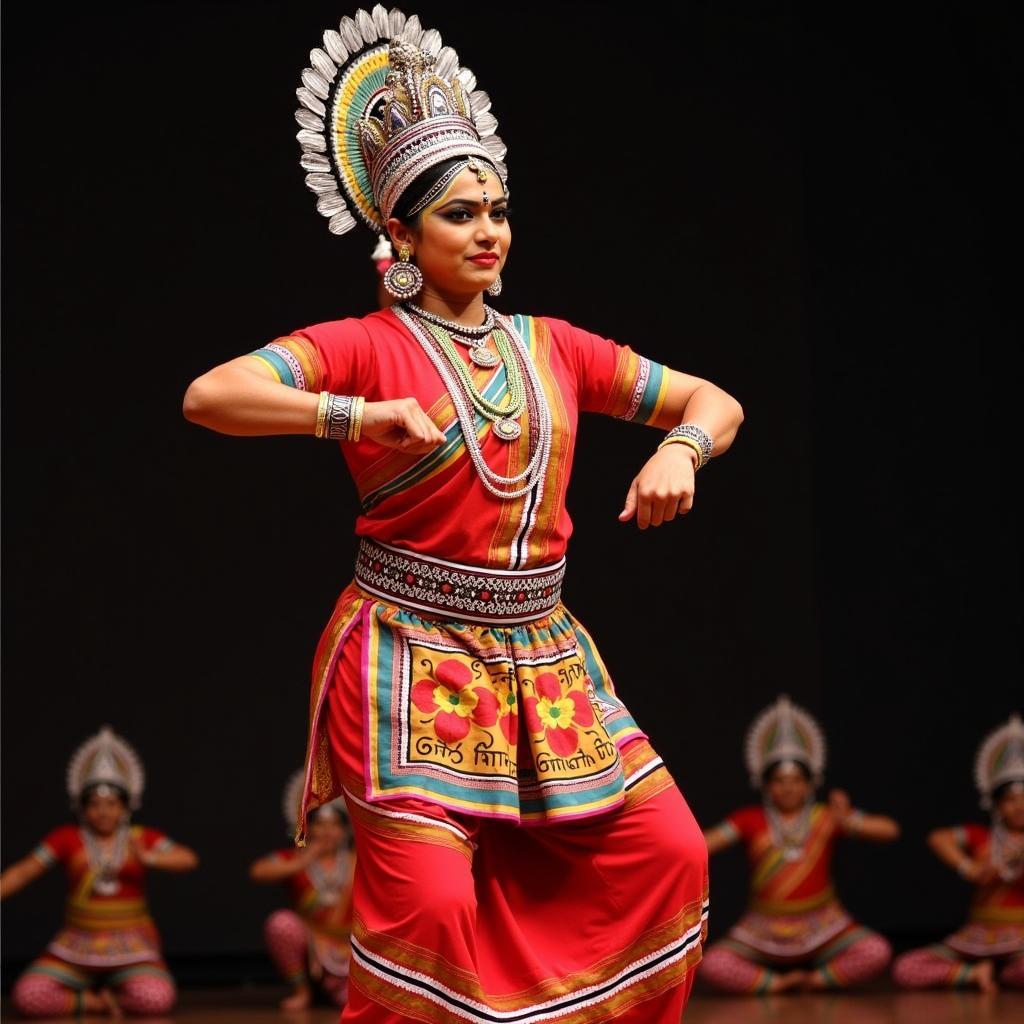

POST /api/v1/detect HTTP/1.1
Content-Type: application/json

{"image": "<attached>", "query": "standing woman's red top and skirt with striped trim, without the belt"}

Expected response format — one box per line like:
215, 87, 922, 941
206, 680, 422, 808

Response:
254, 310, 708, 1024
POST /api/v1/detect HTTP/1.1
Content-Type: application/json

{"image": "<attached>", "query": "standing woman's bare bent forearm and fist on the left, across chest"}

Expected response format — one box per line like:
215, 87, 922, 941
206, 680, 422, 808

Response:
182, 355, 445, 455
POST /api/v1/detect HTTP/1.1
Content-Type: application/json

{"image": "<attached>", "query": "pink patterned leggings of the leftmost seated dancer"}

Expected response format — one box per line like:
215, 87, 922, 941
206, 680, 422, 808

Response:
10, 956, 176, 1017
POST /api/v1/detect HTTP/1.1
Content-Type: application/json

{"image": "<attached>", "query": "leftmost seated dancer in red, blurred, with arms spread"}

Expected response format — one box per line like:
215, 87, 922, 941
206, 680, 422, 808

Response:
0, 726, 199, 1017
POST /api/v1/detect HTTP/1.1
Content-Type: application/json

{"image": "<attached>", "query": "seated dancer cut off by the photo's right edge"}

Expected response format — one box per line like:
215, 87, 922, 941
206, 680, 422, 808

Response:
893, 715, 1024, 992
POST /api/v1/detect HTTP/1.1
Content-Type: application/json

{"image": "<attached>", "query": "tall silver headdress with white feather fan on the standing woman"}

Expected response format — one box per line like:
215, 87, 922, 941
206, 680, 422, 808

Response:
295, 4, 507, 234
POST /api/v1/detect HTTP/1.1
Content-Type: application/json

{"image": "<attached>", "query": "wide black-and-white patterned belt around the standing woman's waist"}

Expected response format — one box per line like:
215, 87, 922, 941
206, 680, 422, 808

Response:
355, 537, 565, 626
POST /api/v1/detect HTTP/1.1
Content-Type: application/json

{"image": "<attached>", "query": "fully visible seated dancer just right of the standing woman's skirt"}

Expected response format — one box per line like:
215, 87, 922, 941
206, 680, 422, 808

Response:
701, 696, 899, 993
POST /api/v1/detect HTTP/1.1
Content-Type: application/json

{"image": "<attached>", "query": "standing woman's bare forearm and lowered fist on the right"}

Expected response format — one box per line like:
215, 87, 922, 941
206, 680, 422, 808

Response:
618, 369, 743, 529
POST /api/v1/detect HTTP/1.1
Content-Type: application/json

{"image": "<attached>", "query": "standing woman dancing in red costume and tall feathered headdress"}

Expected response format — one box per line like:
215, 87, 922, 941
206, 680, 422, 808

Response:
184, 6, 741, 1024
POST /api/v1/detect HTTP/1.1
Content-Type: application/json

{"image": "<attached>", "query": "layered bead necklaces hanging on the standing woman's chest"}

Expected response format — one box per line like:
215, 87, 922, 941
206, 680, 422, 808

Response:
392, 305, 552, 500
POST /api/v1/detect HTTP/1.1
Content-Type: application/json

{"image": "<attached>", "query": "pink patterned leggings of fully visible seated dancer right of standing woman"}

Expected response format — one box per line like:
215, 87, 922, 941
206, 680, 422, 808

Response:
700, 928, 892, 994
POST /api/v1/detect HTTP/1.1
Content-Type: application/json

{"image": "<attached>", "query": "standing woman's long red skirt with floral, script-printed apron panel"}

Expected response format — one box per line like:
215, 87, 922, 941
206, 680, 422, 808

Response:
306, 540, 708, 1024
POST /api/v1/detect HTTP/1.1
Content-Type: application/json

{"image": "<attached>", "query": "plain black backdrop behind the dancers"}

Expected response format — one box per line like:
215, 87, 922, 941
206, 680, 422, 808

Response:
2, 2, 1024, 978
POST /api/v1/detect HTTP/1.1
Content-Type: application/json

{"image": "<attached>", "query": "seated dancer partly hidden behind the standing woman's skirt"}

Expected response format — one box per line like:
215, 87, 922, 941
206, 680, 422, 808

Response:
249, 769, 354, 1010
